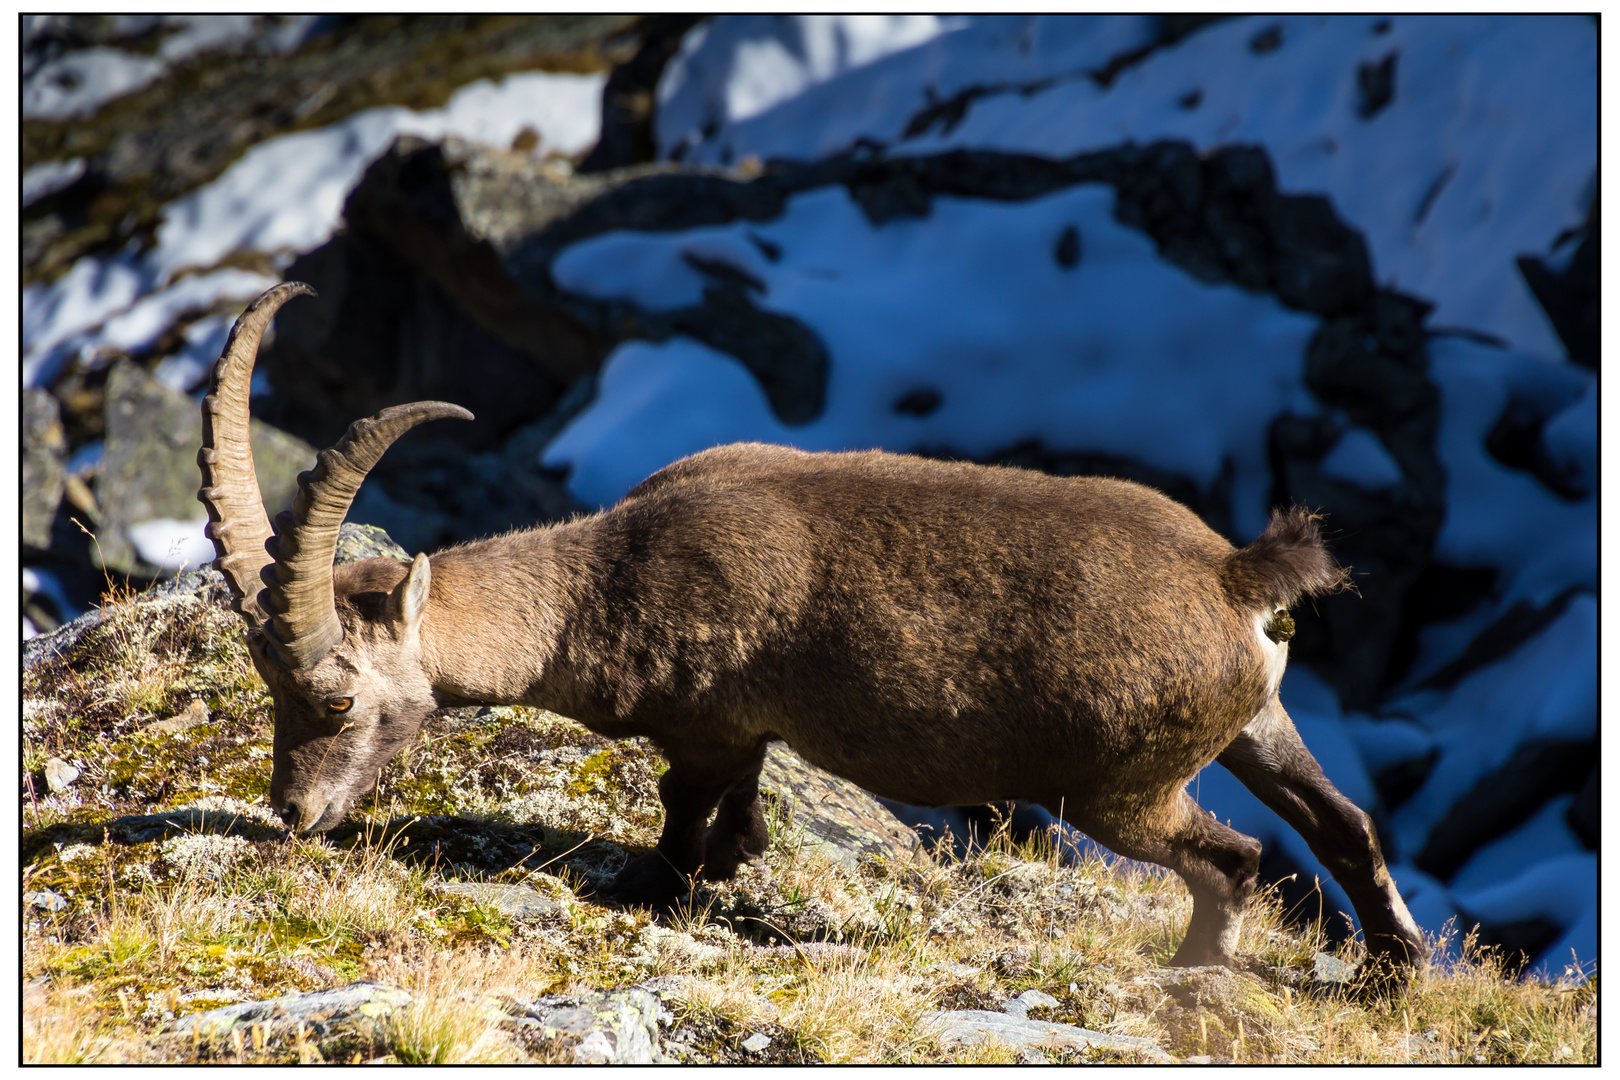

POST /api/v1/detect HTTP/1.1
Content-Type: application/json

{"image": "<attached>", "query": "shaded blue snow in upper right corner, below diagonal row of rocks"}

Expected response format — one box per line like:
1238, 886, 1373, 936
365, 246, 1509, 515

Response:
906, 15, 1597, 356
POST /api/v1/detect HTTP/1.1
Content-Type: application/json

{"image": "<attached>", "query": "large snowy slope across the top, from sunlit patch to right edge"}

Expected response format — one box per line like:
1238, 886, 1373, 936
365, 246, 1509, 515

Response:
659, 15, 1597, 356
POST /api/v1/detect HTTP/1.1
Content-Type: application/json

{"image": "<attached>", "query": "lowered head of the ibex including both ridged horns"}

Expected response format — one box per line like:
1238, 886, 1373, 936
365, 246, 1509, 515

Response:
198, 282, 473, 832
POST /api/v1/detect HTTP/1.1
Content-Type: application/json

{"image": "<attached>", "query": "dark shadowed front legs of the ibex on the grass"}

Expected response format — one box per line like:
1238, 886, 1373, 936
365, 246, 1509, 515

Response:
609, 745, 765, 907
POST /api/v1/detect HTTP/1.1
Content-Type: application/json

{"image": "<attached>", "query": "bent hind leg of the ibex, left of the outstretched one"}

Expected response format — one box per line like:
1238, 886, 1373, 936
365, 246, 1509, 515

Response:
1066, 789, 1260, 968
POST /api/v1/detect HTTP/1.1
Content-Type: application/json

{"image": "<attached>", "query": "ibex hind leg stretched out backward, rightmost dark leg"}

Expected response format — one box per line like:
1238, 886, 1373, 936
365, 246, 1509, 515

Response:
1217, 698, 1427, 973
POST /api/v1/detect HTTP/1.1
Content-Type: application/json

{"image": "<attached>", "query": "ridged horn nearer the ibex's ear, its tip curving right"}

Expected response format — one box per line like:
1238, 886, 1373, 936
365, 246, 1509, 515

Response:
264, 402, 473, 670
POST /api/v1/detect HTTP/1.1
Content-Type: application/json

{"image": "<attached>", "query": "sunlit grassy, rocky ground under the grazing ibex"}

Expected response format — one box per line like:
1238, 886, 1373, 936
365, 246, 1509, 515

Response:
21, 529, 1597, 1062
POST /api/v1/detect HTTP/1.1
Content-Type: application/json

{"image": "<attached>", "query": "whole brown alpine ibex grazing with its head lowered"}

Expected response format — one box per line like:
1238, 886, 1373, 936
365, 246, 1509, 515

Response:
198, 282, 1424, 968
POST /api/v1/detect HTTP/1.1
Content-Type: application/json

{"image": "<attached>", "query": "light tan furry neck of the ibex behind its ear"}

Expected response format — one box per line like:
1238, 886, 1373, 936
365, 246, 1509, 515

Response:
421, 529, 569, 704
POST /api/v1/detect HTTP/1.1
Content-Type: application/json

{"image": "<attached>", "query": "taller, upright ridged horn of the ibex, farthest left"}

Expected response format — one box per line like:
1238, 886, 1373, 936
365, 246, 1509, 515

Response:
198, 282, 316, 627
